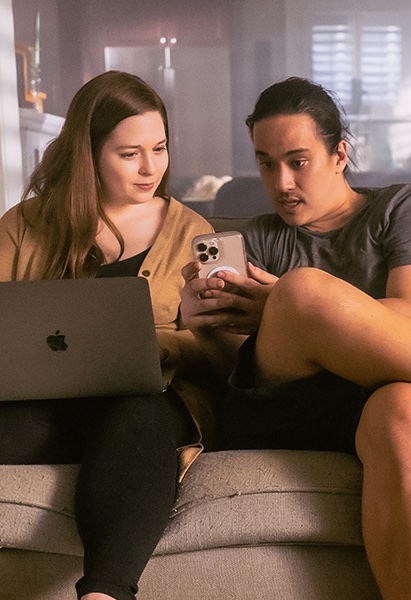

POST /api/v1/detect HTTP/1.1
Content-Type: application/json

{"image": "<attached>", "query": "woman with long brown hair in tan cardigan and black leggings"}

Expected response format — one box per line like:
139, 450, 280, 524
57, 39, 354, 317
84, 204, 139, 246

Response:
0, 72, 211, 600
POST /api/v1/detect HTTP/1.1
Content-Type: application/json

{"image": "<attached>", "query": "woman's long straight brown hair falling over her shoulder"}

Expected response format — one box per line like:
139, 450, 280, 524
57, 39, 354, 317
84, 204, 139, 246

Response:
20, 71, 169, 279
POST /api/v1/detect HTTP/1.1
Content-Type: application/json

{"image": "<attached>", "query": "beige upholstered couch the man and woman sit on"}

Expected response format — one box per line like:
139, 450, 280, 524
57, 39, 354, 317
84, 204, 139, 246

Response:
0, 218, 380, 600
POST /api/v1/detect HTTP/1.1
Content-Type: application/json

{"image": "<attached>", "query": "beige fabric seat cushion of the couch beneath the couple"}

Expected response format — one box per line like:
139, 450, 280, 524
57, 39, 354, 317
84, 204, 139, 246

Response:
0, 450, 362, 556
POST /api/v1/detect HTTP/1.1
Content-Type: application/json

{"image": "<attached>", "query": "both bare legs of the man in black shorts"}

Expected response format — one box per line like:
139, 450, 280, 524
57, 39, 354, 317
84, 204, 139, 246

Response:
255, 268, 411, 600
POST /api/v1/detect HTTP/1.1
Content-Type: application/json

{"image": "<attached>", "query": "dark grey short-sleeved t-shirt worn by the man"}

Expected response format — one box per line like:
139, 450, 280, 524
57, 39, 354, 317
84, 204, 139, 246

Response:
242, 184, 411, 298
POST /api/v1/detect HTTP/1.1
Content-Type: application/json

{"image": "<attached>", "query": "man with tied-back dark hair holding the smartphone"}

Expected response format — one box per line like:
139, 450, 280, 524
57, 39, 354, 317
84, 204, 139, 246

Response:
182, 78, 411, 600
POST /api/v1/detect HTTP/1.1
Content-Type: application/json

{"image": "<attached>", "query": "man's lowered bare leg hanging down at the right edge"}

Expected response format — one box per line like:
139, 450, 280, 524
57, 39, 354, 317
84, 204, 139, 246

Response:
356, 383, 411, 600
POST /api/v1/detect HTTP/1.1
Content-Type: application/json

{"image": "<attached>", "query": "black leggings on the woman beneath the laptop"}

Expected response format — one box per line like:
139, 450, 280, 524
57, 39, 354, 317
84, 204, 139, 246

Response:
0, 390, 193, 600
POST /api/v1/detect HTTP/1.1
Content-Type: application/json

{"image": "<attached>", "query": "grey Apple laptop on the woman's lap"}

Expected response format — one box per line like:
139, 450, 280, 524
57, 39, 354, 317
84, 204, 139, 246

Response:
0, 277, 166, 400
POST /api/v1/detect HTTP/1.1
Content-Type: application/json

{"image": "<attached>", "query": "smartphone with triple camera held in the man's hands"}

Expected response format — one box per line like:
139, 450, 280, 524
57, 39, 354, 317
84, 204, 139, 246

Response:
192, 231, 247, 277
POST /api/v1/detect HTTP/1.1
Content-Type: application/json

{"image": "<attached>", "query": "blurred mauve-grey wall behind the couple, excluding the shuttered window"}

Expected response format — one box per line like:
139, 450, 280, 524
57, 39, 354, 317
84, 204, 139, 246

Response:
13, 0, 411, 177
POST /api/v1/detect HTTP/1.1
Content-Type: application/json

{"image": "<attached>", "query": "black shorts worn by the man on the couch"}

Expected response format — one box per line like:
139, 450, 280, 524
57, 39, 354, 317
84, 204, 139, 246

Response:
218, 336, 372, 454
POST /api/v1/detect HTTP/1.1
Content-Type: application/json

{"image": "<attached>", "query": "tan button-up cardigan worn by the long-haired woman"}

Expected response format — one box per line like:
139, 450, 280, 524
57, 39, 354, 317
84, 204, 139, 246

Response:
0, 198, 217, 477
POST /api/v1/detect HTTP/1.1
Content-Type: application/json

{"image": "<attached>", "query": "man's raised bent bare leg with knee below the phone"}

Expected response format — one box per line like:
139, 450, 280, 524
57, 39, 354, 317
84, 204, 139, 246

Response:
255, 268, 411, 388
